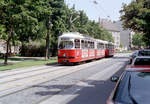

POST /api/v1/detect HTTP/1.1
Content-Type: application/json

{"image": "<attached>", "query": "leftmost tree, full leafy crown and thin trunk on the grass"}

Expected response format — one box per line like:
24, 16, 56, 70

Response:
0, 0, 39, 64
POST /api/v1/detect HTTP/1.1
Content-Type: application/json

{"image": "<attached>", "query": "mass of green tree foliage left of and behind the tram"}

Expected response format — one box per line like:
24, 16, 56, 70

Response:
0, 0, 113, 56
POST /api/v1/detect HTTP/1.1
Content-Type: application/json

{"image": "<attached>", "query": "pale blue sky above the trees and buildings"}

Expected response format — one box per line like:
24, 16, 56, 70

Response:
65, 0, 131, 21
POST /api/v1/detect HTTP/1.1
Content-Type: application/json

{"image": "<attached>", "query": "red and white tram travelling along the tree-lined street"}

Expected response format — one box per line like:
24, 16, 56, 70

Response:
58, 32, 114, 63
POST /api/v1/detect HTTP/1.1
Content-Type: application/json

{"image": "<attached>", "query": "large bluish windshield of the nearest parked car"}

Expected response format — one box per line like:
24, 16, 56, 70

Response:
113, 71, 150, 104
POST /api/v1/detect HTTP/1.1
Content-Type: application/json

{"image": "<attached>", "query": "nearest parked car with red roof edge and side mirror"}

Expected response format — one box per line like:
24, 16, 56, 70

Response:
106, 66, 150, 104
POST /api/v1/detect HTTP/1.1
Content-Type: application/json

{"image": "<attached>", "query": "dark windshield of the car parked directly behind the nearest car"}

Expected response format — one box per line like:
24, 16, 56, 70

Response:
134, 58, 150, 65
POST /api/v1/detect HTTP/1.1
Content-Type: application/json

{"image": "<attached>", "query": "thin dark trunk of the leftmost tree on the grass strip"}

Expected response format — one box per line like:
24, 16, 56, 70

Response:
4, 28, 13, 64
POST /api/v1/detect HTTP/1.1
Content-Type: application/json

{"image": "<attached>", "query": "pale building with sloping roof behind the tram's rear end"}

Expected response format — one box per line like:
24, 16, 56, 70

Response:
99, 18, 120, 49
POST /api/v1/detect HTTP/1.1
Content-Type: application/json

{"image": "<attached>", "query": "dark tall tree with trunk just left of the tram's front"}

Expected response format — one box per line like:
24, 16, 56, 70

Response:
50, 0, 68, 56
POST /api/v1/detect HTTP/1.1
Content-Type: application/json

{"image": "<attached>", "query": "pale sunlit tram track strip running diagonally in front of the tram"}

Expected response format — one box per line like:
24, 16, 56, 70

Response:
0, 59, 112, 97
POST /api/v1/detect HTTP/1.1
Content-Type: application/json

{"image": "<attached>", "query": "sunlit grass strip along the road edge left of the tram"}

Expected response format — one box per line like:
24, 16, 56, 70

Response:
0, 59, 57, 71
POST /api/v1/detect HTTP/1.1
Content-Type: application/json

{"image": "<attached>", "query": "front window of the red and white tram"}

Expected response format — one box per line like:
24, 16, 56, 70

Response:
59, 41, 73, 49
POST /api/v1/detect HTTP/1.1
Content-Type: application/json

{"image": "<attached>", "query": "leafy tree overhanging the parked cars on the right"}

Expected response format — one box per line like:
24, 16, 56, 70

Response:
120, 0, 150, 45
